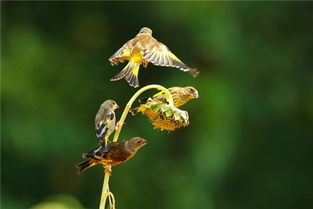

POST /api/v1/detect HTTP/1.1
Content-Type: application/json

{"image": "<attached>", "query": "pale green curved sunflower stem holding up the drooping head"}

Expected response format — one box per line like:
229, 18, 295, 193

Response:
99, 84, 174, 209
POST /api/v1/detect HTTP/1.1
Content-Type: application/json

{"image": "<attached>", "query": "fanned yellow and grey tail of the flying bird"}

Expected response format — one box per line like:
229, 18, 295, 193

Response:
111, 61, 140, 88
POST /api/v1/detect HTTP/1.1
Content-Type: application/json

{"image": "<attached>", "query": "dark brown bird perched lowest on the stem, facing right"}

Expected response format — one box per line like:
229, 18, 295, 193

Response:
75, 137, 147, 175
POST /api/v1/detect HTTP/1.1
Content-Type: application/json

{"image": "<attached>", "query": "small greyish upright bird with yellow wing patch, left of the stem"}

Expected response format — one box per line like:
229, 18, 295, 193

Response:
95, 99, 119, 151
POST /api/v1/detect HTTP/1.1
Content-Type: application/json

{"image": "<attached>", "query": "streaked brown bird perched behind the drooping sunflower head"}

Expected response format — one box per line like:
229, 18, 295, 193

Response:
130, 86, 199, 115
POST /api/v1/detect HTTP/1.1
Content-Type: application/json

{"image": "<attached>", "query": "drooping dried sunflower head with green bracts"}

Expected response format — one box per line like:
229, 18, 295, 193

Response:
132, 98, 189, 131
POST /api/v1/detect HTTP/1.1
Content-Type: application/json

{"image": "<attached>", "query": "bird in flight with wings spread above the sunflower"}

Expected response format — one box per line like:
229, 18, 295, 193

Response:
109, 27, 199, 88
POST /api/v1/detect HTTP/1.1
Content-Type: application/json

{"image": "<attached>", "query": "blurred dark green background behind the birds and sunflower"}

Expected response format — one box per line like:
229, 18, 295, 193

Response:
1, 2, 313, 209
